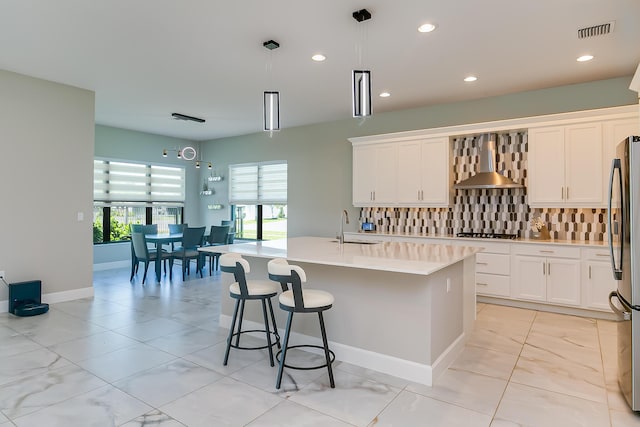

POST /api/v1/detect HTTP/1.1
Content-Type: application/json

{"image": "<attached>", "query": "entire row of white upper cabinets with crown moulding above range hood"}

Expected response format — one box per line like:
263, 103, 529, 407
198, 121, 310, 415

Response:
349, 105, 640, 208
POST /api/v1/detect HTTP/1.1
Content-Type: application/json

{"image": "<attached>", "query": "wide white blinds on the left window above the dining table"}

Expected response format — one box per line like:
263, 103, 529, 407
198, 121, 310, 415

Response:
93, 160, 185, 206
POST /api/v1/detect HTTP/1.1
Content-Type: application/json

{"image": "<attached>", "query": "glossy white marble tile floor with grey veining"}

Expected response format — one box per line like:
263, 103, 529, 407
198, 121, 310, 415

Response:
0, 269, 640, 427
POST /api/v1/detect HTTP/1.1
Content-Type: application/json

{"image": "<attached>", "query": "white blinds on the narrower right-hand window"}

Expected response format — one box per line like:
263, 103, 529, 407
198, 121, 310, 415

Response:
229, 162, 287, 205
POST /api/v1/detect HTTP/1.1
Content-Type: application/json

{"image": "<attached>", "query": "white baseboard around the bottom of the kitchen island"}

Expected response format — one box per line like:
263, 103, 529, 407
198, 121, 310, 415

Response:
220, 314, 465, 386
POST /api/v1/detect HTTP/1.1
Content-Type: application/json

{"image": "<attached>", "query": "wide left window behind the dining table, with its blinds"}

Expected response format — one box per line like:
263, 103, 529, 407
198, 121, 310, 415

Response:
93, 159, 185, 243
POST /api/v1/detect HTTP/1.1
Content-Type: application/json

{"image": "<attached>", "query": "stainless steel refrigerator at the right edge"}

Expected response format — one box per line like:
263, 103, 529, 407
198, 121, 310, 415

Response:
607, 136, 640, 411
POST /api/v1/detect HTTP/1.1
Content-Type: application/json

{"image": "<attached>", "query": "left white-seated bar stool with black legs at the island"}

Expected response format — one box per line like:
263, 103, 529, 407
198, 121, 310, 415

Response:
220, 253, 281, 366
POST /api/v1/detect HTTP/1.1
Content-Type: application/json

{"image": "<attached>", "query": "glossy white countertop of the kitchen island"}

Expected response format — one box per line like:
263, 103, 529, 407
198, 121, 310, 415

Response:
200, 237, 481, 275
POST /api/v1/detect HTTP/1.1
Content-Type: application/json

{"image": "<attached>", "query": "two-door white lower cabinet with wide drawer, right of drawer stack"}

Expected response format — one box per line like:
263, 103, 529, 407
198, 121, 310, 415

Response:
511, 245, 581, 306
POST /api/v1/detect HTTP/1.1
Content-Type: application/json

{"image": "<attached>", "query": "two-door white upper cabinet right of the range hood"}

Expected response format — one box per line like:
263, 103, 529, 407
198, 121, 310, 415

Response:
528, 122, 605, 207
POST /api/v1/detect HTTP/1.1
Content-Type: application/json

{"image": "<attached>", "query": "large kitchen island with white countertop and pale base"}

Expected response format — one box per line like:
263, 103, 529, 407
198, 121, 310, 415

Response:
200, 237, 480, 385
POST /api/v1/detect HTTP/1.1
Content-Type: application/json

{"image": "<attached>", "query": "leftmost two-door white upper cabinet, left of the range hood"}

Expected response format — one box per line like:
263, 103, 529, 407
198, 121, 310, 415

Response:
353, 144, 398, 206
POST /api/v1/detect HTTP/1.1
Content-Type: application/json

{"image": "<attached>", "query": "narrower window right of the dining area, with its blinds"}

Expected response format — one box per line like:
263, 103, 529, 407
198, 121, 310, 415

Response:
229, 162, 287, 240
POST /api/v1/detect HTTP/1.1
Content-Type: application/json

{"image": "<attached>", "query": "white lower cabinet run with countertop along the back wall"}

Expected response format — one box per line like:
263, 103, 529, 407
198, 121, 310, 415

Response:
345, 233, 616, 313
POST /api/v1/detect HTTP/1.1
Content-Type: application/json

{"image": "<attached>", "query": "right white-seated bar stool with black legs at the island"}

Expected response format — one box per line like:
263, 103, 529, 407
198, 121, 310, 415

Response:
267, 258, 336, 389
